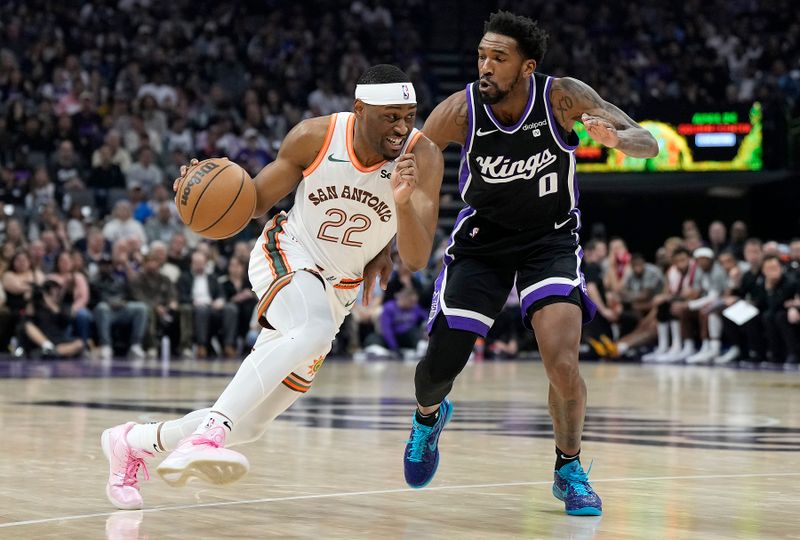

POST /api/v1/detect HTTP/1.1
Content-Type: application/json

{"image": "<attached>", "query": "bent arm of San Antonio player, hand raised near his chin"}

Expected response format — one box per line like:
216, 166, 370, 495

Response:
391, 137, 444, 272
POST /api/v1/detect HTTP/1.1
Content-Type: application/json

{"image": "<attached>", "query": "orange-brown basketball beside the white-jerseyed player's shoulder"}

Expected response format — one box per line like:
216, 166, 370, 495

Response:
175, 158, 256, 240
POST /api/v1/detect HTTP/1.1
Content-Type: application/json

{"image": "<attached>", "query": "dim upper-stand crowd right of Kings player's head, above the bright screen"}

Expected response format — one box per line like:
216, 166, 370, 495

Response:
499, 0, 800, 115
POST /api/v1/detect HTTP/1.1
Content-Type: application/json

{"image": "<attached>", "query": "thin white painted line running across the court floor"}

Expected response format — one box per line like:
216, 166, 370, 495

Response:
0, 472, 800, 529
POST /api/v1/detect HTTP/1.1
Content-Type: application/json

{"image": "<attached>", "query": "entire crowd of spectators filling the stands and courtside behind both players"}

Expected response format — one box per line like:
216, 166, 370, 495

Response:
0, 0, 800, 362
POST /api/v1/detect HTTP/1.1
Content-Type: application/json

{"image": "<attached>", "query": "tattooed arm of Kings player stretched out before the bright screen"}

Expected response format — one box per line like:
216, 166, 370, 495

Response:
550, 77, 658, 158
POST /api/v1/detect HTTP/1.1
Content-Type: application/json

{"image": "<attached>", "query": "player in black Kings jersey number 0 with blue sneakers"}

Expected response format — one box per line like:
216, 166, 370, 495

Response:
404, 11, 658, 515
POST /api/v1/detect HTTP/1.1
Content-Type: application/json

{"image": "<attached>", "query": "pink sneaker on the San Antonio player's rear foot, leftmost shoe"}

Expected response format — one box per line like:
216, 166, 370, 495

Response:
100, 422, 153, 510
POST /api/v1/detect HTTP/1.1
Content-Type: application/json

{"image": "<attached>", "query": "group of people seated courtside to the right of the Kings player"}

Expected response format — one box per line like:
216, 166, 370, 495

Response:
583, 220, 800, 365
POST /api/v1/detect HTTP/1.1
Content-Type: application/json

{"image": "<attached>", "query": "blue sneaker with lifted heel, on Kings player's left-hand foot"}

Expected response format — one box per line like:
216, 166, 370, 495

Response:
403, 399, 453, 488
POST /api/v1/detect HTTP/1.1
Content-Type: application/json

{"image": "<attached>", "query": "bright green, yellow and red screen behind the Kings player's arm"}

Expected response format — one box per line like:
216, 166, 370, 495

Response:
575, 102, 762, 173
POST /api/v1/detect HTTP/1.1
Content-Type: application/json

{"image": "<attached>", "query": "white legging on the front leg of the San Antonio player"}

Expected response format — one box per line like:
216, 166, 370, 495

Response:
207, 272, 337, 432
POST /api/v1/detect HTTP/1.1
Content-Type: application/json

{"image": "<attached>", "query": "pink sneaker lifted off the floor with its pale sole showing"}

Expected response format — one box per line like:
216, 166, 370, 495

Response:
156, 426, 250, 487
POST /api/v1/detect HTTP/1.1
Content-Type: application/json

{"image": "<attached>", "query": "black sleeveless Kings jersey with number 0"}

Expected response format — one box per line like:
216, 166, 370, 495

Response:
459, 73, 580, 236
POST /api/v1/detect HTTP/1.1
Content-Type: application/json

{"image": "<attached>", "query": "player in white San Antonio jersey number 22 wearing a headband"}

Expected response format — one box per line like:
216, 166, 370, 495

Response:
101, 64, 443, 509
